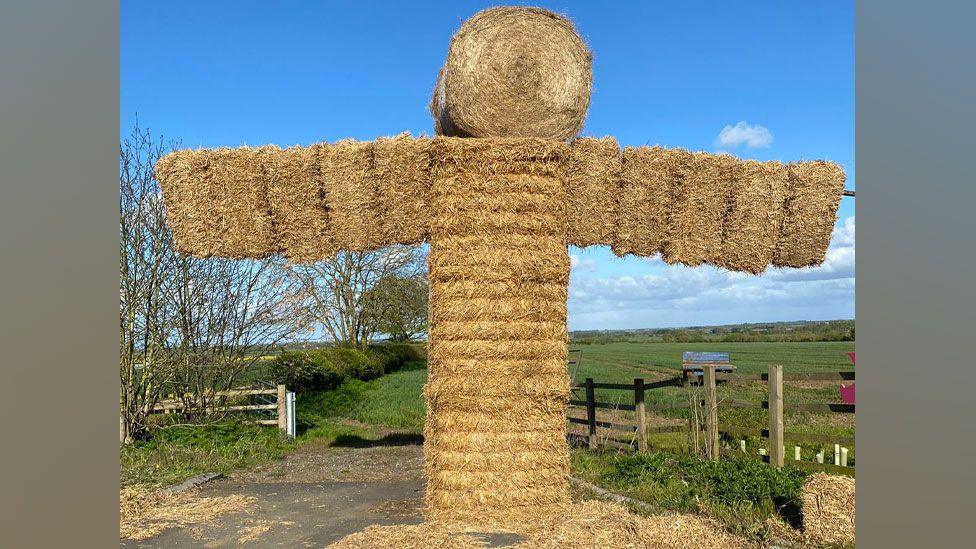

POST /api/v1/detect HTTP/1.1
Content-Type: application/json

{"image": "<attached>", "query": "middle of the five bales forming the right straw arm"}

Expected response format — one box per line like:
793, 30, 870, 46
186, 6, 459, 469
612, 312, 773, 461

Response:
662, 152, 740, 266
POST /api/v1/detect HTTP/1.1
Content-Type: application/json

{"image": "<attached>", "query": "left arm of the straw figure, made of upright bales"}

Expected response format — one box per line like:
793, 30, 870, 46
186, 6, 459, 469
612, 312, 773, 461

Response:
155, 135, 430, 263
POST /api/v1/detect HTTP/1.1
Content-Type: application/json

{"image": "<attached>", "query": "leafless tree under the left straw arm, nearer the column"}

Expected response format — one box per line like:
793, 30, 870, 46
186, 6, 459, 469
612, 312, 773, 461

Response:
288, 246, 424, 348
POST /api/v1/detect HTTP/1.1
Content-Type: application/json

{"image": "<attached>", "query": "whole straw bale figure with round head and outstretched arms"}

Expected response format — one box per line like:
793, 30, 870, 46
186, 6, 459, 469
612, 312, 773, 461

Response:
156, 8, 844, 528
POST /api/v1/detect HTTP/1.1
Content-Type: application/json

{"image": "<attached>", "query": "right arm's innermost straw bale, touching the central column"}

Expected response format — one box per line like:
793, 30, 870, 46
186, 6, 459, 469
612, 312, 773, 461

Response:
566, 137, 623, 247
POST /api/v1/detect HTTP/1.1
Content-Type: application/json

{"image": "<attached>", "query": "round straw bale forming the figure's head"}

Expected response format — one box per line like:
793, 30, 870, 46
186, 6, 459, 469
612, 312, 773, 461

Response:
430, 7, 592, 139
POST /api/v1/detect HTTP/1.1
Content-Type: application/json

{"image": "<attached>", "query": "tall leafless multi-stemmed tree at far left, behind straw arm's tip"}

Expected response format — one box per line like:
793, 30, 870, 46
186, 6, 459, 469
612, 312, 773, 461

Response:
119, 122, 306, 443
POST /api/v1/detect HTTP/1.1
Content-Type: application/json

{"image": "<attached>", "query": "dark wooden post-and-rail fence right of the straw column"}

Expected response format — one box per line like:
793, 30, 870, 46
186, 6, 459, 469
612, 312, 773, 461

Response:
568, 365, 854, 475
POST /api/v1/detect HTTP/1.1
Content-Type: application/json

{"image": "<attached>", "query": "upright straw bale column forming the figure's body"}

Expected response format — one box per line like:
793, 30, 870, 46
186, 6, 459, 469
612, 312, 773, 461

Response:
424, 138, 569, 528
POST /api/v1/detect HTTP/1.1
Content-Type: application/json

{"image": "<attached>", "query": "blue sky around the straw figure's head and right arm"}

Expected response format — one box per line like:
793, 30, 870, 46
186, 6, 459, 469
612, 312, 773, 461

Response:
120, 1, 856, 329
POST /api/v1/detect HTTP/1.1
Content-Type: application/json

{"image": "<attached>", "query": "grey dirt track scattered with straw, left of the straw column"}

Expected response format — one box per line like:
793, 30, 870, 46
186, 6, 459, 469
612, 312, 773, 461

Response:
121, 434, 423, 548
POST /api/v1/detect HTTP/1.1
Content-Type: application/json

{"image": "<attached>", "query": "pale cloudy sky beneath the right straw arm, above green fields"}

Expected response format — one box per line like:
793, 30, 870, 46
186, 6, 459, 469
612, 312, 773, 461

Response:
569, 217, 855, 329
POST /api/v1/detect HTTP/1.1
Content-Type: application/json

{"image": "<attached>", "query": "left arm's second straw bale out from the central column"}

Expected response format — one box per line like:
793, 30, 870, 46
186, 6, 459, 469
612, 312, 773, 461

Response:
319, 139, 382, 252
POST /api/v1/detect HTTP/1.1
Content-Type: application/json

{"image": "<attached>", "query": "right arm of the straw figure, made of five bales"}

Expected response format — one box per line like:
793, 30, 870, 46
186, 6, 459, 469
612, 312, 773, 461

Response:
567, 138, 845, 273
